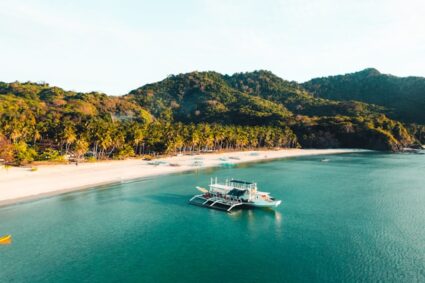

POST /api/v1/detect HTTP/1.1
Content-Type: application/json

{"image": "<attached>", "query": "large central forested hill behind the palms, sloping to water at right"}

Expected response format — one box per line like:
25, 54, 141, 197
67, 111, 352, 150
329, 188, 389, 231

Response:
128, 71, 413, 153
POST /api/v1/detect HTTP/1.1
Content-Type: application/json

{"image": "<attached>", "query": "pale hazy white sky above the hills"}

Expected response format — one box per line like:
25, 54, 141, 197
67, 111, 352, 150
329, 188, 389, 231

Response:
0, 0, 425, 95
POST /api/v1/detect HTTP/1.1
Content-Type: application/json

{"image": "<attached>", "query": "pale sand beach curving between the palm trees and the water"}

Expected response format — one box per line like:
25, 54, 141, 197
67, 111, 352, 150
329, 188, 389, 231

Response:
0, 149, 361, 205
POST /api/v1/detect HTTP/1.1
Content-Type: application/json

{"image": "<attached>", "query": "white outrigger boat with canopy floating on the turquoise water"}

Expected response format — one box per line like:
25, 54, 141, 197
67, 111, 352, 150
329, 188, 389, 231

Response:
189, 178, 282, 212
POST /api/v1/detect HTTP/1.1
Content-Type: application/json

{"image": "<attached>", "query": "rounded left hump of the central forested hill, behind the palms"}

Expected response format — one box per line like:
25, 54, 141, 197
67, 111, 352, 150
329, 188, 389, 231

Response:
127, 72, 291, 125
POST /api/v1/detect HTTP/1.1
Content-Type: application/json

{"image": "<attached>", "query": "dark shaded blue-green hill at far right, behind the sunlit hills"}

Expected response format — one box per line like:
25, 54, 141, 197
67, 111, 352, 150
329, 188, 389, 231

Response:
302, 68, 425, 124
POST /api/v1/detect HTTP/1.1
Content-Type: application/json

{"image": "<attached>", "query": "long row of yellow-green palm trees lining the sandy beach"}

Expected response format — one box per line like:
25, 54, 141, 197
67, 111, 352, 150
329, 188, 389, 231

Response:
0, 118, 299, 165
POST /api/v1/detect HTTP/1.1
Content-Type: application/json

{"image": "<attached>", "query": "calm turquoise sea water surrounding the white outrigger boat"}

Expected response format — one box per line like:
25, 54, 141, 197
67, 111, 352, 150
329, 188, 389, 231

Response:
0, 154, 425, 282
